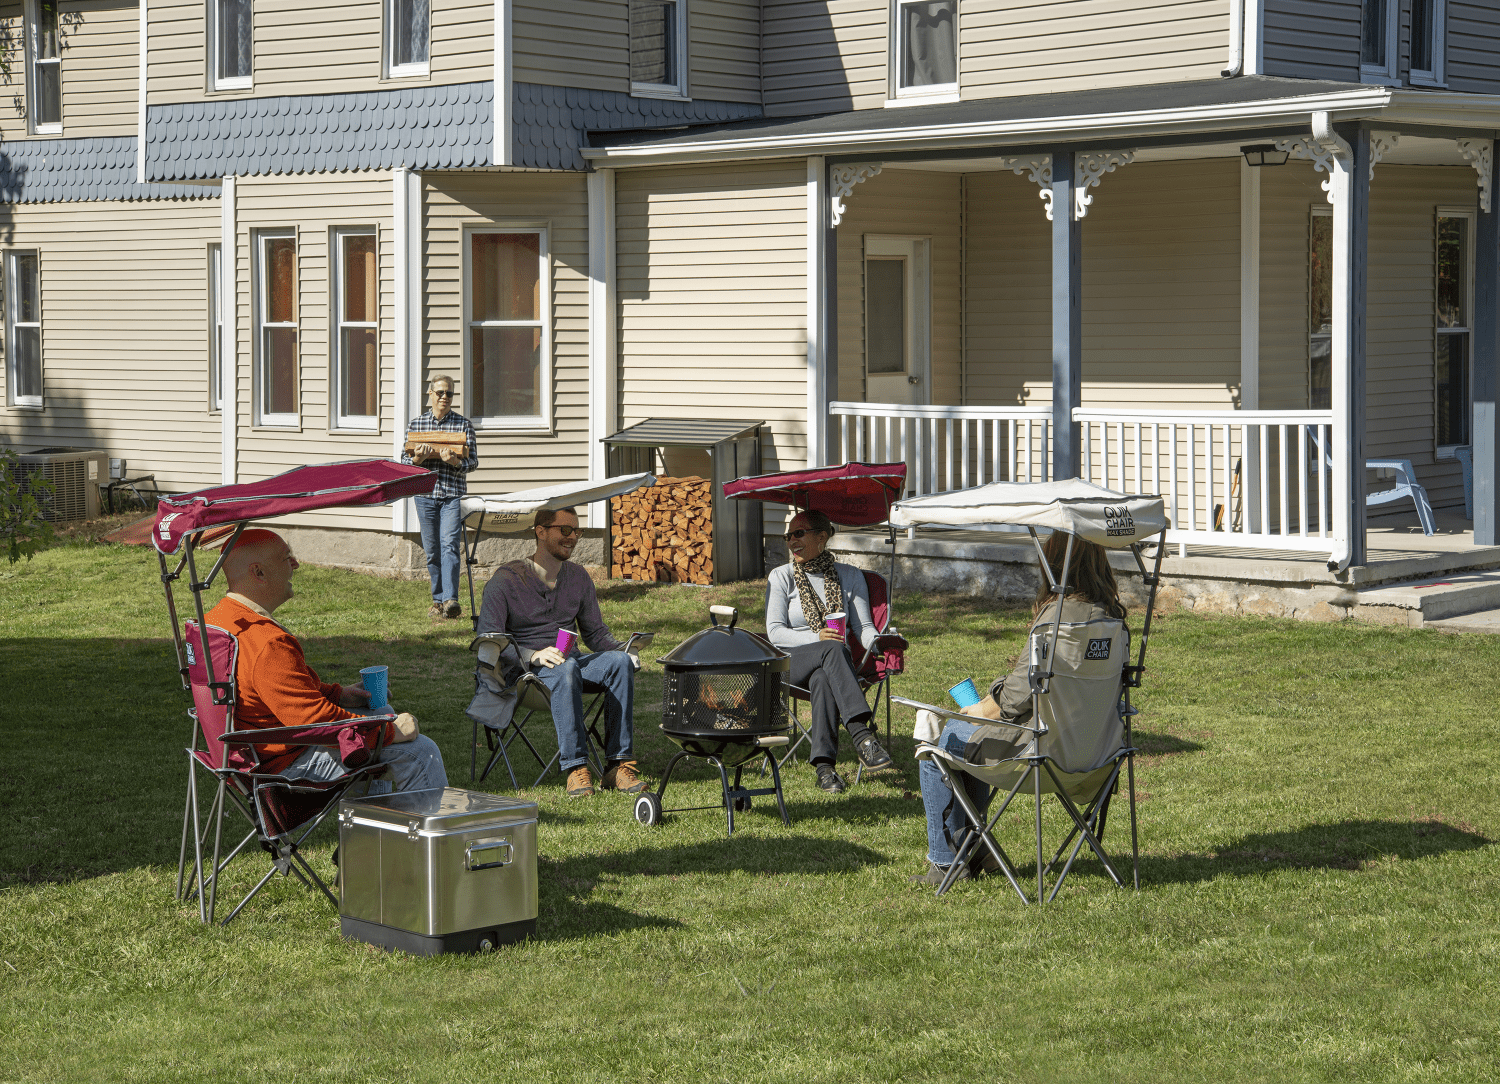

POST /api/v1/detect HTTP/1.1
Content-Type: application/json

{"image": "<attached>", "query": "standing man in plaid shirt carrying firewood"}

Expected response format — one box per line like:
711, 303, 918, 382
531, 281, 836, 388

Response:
401, 376, 479, 618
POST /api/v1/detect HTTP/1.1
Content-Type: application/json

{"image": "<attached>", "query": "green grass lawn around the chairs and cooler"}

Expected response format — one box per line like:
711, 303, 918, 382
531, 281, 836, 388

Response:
0, 530, 1500, 1083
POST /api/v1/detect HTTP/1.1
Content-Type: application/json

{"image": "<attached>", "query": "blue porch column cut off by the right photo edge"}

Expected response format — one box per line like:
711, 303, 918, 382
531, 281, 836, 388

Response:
1469, 148, 1500, 546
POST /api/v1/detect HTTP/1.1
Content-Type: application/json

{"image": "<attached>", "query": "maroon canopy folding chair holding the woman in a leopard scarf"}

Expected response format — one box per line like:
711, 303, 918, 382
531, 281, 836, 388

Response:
725, 463, 911, 783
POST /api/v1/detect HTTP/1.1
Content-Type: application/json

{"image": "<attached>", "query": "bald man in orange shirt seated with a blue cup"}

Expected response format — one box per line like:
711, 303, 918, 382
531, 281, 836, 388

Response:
204, 529, 449, 795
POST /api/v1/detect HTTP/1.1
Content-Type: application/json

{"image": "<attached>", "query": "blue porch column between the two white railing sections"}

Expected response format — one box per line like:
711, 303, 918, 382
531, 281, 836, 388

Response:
1050, 150, 1083, 478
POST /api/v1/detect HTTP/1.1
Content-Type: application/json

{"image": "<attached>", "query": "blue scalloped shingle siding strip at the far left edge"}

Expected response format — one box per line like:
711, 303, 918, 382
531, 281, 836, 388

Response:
0, 135, 219, 204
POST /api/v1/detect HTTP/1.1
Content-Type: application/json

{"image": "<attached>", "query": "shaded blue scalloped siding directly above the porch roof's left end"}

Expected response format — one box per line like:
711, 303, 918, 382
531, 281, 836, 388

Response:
510, 82, 761, 169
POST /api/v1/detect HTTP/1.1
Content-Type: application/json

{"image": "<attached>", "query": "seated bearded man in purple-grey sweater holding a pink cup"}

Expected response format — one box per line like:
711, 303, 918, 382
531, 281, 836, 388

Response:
479, 508, 647, 798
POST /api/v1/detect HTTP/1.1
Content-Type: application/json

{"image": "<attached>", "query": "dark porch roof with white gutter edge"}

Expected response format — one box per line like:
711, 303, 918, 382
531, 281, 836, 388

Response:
582, 75, 1500, 166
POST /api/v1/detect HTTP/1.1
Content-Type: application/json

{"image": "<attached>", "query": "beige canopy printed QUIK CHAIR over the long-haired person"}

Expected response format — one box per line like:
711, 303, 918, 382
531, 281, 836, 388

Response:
891, 478, 1169, 549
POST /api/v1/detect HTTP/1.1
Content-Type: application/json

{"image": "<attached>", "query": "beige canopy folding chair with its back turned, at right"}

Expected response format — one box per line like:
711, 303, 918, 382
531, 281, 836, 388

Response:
891, 478, 1169, 903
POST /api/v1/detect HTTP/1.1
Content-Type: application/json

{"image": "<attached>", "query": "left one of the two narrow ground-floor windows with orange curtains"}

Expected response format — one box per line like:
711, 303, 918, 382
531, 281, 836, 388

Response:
255, 229, 302, 427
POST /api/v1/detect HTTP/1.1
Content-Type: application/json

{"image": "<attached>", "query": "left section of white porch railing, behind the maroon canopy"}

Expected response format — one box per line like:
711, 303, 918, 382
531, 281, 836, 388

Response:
828, 403, 1052, 496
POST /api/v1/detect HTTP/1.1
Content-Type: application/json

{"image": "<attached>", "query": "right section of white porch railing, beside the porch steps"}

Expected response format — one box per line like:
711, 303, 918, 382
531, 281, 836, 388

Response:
1073, 409, 1349, 553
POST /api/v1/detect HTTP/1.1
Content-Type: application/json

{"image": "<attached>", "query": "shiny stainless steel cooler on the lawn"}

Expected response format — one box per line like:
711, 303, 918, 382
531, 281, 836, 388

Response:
339, 787, 537, 957
